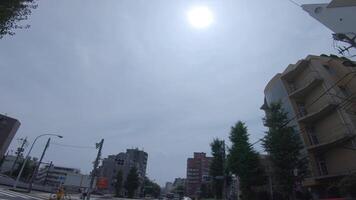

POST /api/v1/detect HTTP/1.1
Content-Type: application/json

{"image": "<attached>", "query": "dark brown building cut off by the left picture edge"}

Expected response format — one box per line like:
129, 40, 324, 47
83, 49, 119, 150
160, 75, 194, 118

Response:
0, 114, 20, 158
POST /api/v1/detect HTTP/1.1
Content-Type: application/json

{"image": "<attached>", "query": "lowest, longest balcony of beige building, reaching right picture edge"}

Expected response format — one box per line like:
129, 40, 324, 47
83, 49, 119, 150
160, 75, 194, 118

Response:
307, 124, 356, 153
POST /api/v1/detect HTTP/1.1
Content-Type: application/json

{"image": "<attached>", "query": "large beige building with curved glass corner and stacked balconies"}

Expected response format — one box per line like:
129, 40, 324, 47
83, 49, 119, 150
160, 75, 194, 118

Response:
262, 55, 356, 198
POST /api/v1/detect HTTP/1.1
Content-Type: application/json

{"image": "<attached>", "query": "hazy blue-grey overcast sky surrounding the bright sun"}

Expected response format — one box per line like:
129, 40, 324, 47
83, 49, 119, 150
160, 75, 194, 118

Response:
0, 0, 336, 185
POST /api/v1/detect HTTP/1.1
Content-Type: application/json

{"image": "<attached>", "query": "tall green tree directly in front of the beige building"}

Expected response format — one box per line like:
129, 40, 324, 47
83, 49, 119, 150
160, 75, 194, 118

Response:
262, 103, 307, 199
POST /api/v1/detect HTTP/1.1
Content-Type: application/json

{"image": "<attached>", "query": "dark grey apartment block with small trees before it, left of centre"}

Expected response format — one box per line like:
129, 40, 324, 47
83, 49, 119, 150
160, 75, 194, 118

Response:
99, 149, 148, 196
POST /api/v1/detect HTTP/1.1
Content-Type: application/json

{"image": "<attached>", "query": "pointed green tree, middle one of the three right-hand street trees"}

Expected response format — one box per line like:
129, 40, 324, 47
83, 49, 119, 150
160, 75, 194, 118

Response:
227, 121, 265, 200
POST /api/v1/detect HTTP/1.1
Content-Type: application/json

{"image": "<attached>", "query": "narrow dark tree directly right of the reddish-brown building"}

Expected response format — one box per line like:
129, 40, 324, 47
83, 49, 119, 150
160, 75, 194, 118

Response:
209, 139, 226, 199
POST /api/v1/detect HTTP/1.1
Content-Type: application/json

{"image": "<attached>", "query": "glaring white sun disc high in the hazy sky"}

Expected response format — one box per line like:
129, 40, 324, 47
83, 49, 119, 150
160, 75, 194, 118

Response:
187, 6, 214, 29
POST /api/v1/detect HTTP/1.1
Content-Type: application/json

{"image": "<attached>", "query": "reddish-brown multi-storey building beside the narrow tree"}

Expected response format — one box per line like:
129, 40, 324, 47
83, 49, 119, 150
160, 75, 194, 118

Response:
186, 152, 212, 198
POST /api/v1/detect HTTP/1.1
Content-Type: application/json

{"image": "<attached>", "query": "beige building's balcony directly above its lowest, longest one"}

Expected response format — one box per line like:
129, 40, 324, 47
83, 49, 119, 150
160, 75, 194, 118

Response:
298, 102, 337, 124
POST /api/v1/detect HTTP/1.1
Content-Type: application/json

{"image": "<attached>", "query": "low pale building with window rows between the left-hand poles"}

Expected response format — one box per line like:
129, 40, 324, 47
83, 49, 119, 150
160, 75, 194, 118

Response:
36, 165, 80, 186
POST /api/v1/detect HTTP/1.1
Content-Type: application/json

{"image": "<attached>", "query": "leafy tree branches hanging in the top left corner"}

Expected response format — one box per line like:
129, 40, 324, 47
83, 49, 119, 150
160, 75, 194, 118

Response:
0, 0, 37, 39
